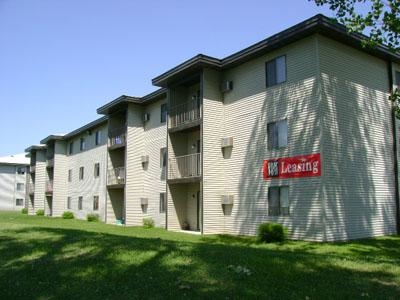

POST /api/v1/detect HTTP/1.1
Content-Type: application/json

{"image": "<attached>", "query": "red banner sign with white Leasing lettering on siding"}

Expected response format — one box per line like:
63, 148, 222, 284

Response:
263, 153, 321, 180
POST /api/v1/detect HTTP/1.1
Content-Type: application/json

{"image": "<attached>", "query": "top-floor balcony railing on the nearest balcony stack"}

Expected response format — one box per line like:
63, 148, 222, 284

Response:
168, 99, 201, 128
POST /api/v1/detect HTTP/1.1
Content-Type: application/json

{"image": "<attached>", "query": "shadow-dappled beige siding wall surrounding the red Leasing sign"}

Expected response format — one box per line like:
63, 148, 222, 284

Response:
217, 37, 323, 240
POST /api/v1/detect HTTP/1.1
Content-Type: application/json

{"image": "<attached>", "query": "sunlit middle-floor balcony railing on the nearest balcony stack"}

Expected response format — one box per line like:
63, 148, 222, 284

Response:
168, 153, 201, 179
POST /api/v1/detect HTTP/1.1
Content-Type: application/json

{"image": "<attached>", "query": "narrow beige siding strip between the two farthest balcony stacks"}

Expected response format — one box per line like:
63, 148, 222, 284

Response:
32, 150, 47, 214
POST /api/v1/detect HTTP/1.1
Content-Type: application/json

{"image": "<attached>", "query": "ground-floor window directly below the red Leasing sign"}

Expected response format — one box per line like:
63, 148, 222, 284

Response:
268, 186, 289, 216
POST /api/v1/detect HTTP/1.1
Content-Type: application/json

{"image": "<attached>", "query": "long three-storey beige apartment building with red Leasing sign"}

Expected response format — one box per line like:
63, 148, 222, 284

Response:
24, 15, 400, 241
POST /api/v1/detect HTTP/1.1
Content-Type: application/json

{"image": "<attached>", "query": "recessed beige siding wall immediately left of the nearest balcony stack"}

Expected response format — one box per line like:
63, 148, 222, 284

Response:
142, 99, 167, 228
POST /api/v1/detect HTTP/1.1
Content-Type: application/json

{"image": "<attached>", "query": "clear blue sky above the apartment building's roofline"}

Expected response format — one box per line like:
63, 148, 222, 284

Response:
0, 0, 333, 156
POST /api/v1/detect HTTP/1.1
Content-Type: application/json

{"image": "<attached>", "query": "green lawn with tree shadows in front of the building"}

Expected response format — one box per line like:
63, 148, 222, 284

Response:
0, 212, 400, 299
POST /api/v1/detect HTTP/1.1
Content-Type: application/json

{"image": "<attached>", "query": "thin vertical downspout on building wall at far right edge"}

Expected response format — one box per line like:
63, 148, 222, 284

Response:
388, 61, 400, 234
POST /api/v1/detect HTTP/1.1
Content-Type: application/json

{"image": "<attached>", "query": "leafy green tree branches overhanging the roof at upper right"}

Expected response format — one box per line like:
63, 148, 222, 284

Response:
308, 0, 400, 119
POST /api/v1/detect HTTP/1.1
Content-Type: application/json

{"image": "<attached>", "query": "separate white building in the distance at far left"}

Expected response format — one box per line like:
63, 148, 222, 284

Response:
0, 154, 29, 210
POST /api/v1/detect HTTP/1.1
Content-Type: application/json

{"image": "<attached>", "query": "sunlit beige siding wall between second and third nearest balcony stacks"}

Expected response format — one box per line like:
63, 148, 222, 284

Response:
67, 124, 108, 221
